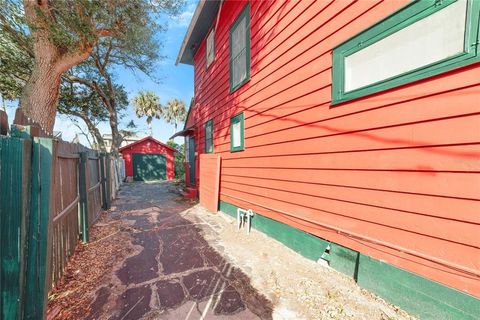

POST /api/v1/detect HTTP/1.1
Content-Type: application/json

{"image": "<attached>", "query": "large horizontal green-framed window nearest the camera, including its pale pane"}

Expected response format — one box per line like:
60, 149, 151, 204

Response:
332, 0, 480, 104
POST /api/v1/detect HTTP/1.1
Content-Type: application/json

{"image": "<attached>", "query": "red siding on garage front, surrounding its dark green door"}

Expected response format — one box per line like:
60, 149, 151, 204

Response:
121, 139, 175, 180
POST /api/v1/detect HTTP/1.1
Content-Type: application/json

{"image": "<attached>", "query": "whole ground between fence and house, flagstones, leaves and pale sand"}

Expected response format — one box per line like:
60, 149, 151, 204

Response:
48, 182, 412, 320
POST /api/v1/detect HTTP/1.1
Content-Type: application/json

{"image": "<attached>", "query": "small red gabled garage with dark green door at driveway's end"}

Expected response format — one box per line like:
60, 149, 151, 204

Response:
119, 137, 176, 181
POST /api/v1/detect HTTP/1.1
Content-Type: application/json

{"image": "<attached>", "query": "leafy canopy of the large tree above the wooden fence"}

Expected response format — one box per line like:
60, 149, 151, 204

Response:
0, 0, 184, 131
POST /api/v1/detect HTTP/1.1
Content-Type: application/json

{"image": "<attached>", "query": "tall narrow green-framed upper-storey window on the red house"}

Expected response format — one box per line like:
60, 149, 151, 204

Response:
230, 4, 250, 92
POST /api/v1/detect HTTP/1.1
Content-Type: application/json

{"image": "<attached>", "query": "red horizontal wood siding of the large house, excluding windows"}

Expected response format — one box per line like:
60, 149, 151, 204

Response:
190, 0, 480, 297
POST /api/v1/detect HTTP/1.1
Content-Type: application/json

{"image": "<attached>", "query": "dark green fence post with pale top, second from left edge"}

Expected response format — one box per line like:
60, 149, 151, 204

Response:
24, 138, 56, 319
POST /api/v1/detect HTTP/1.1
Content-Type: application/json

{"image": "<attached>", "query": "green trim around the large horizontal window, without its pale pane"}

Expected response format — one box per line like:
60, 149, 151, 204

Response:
332, 0, 480, 105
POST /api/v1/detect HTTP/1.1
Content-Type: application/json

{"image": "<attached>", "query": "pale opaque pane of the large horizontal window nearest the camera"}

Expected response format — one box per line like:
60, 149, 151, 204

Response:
345, 0, 467, 92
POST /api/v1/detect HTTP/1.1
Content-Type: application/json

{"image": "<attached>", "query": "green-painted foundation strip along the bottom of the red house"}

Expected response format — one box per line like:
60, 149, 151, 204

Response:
220, 201, 480, 320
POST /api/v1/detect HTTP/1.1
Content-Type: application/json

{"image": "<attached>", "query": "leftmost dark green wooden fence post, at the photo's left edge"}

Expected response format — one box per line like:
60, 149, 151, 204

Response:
0, 137, 31, 319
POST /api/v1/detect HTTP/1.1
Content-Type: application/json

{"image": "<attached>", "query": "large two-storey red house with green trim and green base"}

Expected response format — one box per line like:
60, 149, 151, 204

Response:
177, 0, 480, 319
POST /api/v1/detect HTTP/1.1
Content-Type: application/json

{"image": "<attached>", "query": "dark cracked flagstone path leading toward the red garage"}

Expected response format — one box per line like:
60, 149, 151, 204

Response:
86, 182, 273, 320
